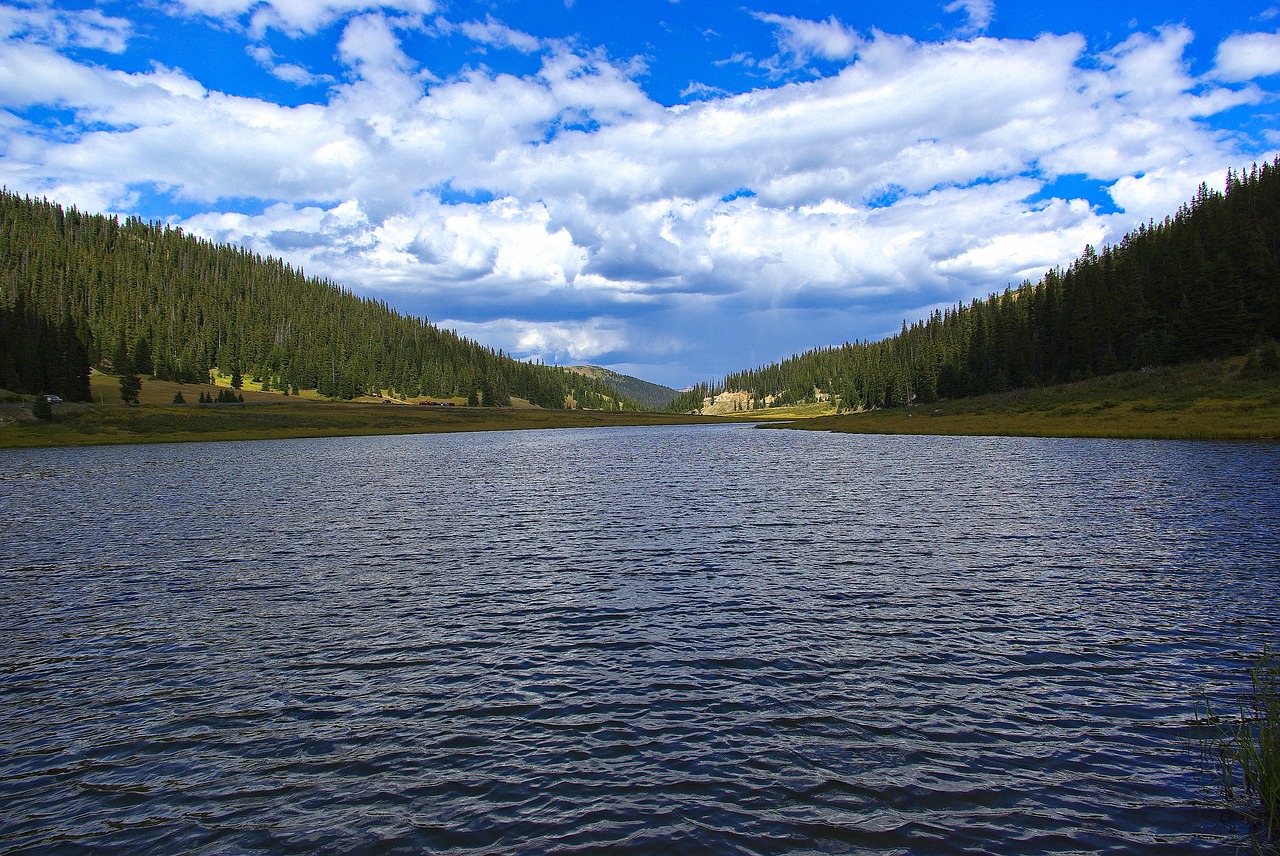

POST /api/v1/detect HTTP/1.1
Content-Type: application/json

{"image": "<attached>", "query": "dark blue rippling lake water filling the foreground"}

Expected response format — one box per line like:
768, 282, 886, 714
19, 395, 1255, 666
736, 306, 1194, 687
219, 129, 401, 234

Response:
0, 427, 1280, 853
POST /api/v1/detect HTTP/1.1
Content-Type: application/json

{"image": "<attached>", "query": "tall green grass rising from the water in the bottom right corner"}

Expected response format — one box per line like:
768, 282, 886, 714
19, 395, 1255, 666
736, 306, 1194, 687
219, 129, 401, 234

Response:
1203, 646, 1280, 852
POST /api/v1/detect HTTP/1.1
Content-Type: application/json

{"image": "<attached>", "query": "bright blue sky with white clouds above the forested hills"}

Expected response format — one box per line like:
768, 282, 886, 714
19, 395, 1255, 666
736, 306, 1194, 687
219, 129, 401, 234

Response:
0, 0, 1280, 386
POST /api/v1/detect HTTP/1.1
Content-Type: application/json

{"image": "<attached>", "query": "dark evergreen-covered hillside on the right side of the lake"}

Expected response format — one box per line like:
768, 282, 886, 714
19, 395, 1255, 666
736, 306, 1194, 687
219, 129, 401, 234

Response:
672, 159, 1280, 411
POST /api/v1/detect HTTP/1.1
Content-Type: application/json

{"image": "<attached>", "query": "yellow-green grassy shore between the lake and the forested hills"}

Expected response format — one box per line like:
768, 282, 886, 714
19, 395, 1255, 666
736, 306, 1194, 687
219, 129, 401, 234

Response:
0, 358, 1280, 448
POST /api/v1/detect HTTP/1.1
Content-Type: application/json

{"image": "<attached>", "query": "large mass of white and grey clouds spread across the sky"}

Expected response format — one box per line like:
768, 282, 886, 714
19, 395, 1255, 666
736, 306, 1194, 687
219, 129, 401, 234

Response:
0, 0, 1272, 377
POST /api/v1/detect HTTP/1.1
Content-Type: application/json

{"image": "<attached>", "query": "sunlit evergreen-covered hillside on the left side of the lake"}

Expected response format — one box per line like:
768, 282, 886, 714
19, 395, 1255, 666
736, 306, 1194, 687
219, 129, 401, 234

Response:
0, 191, 636, 409
